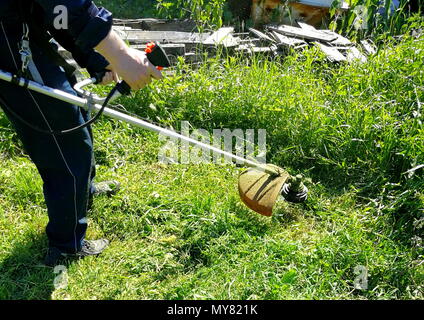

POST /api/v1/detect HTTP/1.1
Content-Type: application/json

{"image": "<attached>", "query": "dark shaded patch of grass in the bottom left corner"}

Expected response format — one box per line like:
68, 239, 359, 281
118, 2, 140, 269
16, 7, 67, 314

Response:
0, 234, 57, 300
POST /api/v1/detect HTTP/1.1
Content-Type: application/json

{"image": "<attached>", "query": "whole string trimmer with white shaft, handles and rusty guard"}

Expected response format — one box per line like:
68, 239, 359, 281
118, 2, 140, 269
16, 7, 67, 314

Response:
0, 43, 307, 216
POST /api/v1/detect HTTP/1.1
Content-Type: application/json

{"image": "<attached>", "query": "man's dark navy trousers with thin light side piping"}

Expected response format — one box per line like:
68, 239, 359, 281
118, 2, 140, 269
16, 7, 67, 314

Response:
0, 22, 94, 253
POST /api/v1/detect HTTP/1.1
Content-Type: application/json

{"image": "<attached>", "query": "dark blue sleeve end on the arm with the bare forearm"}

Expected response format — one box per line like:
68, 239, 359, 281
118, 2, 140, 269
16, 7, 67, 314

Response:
35, 0, 112, 52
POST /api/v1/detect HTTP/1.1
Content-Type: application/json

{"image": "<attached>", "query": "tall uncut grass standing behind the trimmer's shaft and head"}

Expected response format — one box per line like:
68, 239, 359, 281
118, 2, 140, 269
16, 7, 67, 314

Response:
117, 18, 424, 248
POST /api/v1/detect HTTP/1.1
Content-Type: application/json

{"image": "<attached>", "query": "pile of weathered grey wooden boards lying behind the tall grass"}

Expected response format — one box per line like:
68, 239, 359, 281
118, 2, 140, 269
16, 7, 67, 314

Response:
61, 19, 376, 73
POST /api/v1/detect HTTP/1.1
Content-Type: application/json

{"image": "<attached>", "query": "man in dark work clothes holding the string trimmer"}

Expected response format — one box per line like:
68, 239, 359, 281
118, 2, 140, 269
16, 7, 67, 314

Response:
0, 0, 162, 266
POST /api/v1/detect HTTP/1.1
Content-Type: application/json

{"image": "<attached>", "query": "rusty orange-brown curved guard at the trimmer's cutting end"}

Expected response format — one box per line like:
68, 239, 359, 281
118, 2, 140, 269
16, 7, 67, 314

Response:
239, 164, 290, 217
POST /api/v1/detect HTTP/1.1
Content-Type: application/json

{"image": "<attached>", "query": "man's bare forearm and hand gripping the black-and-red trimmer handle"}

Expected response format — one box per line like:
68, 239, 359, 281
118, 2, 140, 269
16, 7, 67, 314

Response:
95, 31, 162, 90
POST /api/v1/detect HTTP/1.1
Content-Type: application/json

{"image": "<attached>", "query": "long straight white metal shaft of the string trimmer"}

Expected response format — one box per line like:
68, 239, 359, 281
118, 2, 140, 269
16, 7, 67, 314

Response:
0, 70, 279, 175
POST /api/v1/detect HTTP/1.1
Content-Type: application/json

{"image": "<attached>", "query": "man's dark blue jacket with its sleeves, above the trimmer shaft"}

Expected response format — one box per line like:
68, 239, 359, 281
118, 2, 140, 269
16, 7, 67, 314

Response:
0, 0, 112, 73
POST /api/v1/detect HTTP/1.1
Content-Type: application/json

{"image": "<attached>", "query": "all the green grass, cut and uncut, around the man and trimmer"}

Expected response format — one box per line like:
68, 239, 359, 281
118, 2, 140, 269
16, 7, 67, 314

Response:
0, 22, 424, 299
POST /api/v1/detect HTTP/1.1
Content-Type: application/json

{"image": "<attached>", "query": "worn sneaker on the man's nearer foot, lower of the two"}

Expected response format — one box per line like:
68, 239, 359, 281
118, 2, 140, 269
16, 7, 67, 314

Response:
44, 239, 109, 267
